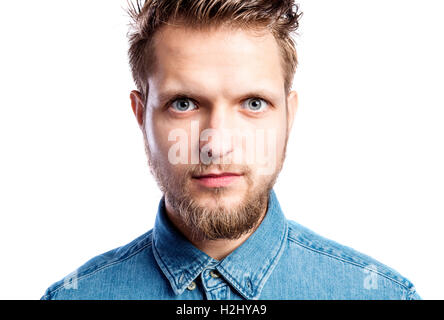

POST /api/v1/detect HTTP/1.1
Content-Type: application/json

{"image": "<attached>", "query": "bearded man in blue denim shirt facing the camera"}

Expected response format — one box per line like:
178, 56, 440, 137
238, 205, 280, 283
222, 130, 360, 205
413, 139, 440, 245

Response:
42, 0, 419, 299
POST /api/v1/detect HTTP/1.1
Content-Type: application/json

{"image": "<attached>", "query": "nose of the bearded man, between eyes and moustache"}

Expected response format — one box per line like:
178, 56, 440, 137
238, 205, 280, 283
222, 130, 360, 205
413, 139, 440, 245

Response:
199, 105, 233, 161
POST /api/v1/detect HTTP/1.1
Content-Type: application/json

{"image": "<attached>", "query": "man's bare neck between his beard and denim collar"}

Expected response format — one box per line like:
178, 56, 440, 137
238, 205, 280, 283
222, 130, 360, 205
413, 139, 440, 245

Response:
165, 197, 267, 260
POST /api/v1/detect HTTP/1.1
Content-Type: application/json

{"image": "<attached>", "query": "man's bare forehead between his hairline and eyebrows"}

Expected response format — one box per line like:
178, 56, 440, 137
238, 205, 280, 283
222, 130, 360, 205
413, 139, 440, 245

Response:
149, 25, 284, 99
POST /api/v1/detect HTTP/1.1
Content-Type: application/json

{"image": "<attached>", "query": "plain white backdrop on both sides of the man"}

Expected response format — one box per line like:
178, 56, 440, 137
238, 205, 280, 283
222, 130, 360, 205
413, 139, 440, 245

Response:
0, 0, 444, 299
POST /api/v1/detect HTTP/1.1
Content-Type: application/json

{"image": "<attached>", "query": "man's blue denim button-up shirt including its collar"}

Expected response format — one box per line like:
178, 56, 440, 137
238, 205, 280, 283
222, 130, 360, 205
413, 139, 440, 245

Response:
41, 190, 420, 300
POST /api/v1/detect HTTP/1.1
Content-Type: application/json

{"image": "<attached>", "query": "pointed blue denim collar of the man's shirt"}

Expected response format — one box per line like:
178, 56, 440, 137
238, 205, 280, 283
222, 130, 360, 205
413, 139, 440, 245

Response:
153, 189, 288, 299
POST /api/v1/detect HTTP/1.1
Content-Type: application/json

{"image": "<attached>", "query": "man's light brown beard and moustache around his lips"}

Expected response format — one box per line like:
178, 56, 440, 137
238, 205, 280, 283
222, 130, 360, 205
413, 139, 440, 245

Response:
145, 132, 288, 241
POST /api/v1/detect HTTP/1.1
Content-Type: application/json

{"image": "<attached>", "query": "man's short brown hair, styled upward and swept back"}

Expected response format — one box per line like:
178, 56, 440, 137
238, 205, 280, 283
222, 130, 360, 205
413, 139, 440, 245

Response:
128, 0, 302, 103
